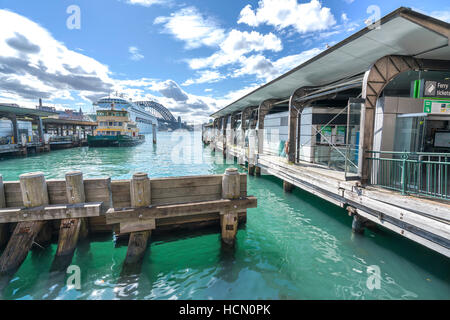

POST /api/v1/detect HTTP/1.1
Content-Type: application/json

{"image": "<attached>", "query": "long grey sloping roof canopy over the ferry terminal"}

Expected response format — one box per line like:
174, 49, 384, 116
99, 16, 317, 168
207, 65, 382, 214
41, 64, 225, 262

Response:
211, 7, 450, 118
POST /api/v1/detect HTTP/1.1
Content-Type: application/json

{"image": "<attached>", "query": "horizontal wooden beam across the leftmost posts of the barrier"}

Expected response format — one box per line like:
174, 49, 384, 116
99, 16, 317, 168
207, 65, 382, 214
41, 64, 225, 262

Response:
0, 202, 102, 223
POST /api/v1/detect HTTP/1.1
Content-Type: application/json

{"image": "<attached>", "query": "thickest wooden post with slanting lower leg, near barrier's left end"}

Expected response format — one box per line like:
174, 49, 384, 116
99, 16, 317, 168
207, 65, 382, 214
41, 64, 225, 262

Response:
0, 172, 48, 274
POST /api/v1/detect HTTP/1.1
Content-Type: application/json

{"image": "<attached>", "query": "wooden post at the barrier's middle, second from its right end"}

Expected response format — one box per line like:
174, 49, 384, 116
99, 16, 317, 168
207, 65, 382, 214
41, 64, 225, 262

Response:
124, 173, 151, 265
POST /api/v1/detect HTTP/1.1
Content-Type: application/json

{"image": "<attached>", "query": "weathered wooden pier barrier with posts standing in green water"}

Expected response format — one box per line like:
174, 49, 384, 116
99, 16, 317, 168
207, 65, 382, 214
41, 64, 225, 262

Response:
0, 169, 257, 274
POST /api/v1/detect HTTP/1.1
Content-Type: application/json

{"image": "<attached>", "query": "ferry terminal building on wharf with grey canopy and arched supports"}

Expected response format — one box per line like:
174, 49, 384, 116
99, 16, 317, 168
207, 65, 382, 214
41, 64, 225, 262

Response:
203, 7, 450, 257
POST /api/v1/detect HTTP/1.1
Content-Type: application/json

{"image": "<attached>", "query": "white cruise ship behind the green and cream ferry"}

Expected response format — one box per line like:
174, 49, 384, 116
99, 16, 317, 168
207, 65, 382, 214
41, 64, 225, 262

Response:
94, 96, 158, 134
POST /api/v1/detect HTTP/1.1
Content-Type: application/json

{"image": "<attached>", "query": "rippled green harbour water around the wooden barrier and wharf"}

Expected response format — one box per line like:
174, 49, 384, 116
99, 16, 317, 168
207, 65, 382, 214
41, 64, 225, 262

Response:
0, 132, 450, 299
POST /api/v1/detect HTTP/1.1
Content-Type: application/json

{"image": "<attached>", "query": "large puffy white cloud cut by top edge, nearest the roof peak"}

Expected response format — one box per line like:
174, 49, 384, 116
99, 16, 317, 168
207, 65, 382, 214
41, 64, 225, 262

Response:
238, 0, 336, 33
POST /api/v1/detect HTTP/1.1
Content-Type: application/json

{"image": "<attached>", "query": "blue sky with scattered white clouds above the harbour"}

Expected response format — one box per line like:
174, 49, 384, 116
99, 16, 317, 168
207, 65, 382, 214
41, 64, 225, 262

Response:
0, 0, 450, 123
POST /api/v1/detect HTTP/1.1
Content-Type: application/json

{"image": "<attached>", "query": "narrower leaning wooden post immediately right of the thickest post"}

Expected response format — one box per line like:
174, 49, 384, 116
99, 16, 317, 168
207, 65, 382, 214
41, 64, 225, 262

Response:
56, 171, 88, 256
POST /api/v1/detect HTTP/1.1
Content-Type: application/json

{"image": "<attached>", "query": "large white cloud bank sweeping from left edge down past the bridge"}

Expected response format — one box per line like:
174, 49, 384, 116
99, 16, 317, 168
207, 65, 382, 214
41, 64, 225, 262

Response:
0, 10, 219, 121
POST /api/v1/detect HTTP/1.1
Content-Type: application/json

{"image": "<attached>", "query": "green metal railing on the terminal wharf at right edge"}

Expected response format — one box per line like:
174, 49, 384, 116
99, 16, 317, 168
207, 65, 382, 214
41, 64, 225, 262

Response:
367, 151, 450, 200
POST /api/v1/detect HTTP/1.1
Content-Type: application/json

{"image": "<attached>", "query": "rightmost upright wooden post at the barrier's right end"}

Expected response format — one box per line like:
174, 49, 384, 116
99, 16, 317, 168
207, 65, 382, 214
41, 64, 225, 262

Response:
220, 168, 241, 246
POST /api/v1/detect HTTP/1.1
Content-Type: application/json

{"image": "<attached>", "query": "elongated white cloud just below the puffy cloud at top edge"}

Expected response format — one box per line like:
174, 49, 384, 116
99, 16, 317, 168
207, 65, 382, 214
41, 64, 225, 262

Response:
188, 29, 283, 69
